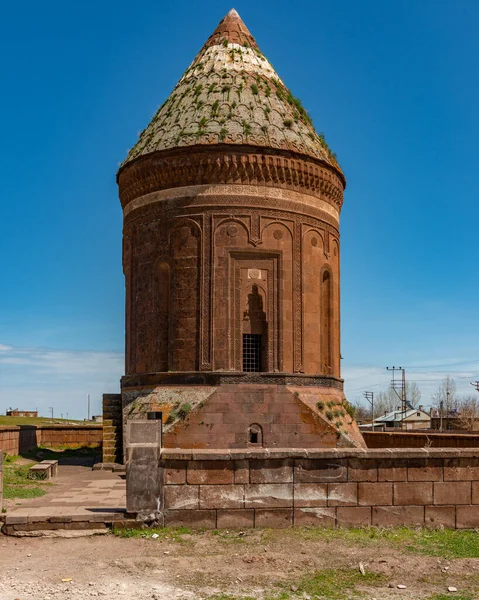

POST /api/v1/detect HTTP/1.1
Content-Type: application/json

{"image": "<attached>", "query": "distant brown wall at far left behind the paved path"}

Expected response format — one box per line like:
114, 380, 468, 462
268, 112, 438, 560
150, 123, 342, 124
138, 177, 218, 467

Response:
0, 425, 103, 454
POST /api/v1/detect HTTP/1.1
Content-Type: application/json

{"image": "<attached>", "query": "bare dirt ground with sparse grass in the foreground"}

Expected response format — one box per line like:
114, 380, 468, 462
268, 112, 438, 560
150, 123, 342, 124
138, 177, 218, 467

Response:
0, 530, 479, 600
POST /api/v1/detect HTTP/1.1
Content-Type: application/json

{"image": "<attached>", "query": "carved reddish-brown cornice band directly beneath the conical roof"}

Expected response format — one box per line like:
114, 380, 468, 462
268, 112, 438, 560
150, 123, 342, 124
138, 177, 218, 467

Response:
117, 145, 346, 211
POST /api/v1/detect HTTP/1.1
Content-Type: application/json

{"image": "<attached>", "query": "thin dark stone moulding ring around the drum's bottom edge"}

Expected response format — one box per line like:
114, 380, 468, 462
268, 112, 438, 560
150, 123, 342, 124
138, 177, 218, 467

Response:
121, 371, 343, 390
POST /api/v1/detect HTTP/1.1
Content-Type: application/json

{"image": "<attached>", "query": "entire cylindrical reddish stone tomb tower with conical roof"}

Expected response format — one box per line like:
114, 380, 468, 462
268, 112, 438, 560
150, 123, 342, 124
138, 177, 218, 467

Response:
118, 10, 363, 448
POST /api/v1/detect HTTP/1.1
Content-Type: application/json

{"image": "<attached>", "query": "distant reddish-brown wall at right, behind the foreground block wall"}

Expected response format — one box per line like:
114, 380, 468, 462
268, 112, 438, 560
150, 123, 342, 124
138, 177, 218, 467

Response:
363, 431, 479, 448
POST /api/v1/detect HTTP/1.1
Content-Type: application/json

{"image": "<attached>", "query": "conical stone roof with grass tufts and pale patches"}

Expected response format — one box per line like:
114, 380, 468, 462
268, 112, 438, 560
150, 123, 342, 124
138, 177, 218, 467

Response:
122, 9, 341, 173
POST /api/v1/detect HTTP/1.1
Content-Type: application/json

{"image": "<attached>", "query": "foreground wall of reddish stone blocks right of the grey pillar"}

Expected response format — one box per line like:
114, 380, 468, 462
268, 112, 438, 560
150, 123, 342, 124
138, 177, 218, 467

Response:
155, 449, 479, 529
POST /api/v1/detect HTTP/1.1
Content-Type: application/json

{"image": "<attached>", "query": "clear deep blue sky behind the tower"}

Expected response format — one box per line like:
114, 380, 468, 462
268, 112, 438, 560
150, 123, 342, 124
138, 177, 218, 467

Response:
0, 0, 479, 418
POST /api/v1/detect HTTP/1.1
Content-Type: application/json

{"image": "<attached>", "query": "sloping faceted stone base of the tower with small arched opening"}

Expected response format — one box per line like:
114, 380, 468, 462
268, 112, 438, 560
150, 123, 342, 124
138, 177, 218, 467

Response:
122, 380, 365, 449
